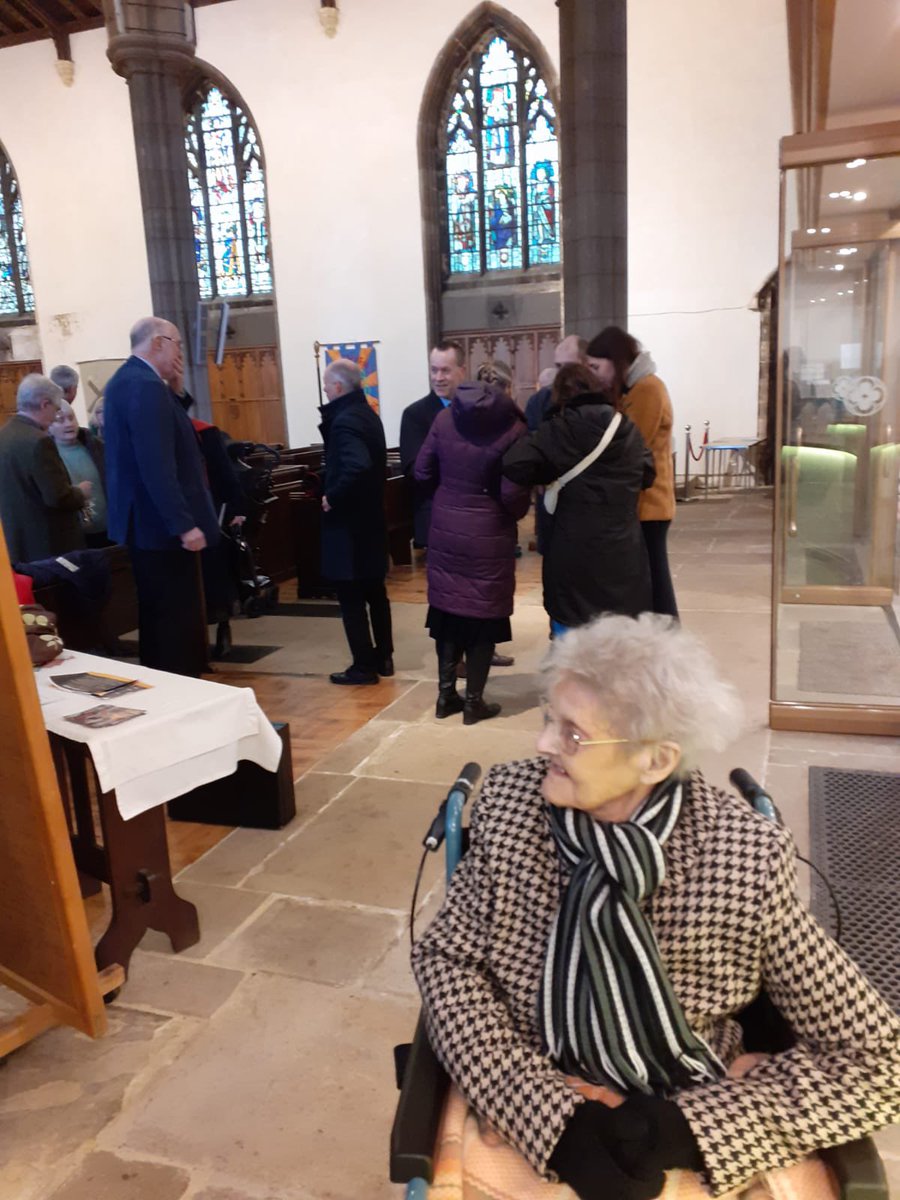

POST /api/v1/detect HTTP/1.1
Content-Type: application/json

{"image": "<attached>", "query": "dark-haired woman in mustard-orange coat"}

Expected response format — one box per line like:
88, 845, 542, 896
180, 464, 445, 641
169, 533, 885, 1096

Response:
587, 325, 678, 618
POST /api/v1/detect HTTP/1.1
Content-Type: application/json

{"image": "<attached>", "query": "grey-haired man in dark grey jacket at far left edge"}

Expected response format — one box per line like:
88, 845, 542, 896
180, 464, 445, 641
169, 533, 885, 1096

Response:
0, 374, 91, 563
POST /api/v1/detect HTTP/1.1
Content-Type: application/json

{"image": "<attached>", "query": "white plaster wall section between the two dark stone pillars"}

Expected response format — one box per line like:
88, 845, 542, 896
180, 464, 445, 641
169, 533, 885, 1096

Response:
197, 0, 558, 445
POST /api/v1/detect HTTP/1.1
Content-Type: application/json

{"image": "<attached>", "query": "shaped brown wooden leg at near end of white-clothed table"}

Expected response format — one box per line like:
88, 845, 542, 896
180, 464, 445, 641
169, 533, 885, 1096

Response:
95, 792, 200, 972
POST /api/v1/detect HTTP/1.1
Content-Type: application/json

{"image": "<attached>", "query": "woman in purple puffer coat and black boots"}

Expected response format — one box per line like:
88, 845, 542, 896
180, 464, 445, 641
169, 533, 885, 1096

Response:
415, 383, 529, 725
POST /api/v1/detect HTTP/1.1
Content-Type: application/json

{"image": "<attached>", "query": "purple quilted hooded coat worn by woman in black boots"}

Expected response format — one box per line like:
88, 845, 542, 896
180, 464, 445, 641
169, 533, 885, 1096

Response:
415, 384, 529, 618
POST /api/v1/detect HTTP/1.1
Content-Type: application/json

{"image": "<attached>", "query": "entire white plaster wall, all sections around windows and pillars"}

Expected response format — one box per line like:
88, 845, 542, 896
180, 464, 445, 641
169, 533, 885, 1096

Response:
0, 0, 790, 450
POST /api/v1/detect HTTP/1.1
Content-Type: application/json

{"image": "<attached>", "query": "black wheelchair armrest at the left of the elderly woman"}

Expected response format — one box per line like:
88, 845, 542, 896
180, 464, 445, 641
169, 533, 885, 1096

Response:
390, 1015, 450, 1183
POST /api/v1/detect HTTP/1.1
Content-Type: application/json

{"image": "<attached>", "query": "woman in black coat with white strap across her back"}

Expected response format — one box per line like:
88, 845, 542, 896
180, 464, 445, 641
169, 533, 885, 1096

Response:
503, 362, 653, 634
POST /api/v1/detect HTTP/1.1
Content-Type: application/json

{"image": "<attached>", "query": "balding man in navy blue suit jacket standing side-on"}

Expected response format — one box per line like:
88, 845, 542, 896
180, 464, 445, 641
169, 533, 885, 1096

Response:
104, 317, 220, 677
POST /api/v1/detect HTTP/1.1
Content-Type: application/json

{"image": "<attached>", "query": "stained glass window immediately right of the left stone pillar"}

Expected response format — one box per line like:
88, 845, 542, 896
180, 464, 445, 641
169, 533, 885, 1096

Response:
185, 86, 272, 299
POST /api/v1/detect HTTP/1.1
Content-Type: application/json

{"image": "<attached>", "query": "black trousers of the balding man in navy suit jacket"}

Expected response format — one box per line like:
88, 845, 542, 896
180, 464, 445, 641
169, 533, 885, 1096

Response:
128, 546, 209, 678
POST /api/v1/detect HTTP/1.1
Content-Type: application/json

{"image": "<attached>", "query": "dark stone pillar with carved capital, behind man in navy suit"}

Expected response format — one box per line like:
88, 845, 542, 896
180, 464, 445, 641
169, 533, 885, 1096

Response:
104, 0, 210, 420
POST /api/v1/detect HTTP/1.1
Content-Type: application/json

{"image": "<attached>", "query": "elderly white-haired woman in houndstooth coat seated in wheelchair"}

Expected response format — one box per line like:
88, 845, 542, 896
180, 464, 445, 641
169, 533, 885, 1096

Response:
413, 613, 900, 1200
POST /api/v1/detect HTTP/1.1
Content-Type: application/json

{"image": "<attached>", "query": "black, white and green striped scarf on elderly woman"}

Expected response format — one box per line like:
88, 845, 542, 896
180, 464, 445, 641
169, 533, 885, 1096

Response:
539, 778, 725, 1094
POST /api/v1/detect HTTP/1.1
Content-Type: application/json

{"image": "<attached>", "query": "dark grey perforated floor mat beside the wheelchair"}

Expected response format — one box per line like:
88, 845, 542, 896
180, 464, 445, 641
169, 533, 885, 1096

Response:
809, 767, 900, 1013
